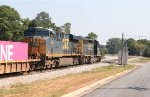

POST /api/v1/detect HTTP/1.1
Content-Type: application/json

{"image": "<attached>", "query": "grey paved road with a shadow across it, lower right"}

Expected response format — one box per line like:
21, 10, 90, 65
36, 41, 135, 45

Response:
83, 63, 150, 97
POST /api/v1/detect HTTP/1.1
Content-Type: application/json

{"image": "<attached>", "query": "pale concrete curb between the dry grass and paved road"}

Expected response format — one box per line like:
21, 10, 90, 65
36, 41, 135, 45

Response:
61, 66, 138, 97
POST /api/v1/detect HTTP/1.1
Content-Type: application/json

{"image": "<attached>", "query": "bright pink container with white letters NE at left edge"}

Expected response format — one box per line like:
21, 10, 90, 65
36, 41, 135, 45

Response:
0, 41, 28, 60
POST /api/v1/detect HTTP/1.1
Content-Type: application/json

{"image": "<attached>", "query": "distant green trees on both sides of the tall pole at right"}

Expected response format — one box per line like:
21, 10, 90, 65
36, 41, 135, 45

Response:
106, 38, 150, 57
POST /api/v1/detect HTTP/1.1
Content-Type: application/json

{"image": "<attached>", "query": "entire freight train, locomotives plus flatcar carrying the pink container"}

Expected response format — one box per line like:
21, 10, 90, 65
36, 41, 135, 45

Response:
0, 27, 101, 74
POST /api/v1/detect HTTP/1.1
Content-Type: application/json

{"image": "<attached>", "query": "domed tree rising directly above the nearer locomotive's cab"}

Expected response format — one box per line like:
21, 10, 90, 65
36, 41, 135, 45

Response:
30, 11, 52, 28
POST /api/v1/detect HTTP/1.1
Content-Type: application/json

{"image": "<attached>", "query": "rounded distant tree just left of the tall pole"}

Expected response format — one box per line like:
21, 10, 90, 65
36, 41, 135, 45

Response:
106, 38, 122, 54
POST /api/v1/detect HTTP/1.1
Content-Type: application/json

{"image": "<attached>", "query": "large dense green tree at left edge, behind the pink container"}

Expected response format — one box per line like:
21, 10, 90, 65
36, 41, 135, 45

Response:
0, 5, 23, 41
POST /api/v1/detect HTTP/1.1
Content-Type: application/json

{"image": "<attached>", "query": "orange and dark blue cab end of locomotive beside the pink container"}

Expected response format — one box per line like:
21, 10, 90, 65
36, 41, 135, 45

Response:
22, 27, 54, 59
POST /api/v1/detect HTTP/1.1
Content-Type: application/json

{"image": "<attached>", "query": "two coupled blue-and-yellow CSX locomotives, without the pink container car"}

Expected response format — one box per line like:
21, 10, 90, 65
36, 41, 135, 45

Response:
22, 27, 101, 70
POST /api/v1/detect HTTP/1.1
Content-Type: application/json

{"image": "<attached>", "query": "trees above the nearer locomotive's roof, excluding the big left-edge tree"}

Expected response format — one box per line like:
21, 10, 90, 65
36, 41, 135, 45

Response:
28, 11, 71, 33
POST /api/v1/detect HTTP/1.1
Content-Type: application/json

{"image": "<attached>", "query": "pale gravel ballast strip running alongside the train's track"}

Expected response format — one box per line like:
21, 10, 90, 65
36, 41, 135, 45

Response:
0, 63, 109, 88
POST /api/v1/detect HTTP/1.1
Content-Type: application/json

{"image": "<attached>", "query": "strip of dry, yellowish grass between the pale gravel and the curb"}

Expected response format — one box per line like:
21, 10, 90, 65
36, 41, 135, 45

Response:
0, 65, 134, 97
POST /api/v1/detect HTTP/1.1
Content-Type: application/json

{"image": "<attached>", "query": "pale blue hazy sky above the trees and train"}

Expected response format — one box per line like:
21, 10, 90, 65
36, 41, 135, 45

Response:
0, 0, 150, 45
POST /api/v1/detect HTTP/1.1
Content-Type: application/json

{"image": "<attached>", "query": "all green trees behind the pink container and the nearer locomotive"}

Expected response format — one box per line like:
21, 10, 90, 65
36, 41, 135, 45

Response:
0, 5, 71, 41
